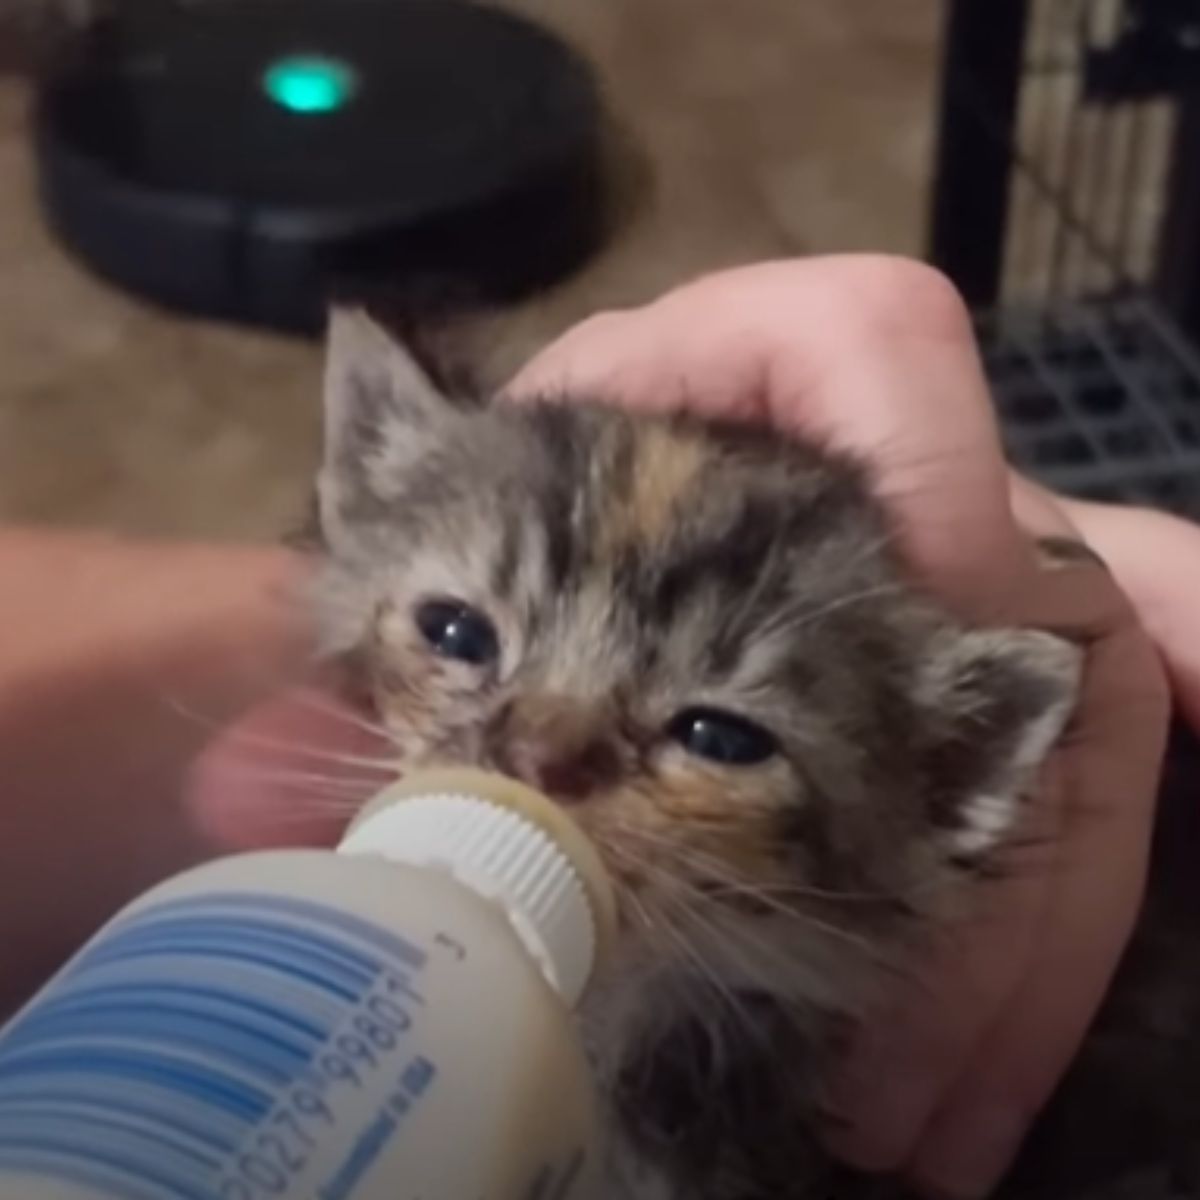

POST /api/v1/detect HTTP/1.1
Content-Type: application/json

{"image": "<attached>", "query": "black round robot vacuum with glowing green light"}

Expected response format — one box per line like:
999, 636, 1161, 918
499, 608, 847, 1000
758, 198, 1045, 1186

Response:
35, 0, 604, 332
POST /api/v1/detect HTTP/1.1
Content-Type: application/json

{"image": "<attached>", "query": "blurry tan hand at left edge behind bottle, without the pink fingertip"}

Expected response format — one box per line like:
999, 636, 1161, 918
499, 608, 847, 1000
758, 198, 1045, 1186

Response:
0, 529, 308, 1013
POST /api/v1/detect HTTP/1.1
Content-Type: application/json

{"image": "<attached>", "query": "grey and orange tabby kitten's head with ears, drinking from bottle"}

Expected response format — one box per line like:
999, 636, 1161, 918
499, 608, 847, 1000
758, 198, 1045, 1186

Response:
309, 312, 1076, 1022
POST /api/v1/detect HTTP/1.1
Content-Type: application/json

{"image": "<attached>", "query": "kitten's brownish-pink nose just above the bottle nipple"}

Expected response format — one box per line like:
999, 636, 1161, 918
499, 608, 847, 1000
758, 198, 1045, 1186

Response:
488, 696, 620, 804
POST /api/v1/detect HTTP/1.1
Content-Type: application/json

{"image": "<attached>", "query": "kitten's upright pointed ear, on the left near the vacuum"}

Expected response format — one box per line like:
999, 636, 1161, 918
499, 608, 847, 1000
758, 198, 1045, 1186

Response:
318, 307, 457, 535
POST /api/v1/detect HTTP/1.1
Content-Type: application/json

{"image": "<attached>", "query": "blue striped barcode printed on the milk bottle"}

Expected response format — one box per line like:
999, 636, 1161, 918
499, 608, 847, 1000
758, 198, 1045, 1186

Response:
0, 893, 434, 1200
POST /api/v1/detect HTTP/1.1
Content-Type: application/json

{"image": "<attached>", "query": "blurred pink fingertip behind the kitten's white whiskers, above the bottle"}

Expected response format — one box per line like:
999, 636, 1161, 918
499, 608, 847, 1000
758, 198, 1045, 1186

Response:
185, 686, 395, 850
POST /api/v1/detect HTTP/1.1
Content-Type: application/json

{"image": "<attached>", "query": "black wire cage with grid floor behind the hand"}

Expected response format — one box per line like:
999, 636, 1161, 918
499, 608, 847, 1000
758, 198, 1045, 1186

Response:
930, 0, 1200, 517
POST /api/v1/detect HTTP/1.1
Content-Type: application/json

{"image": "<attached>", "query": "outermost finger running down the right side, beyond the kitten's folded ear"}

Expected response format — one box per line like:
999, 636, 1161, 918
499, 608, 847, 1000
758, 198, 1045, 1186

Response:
911, 570, 1166, 1196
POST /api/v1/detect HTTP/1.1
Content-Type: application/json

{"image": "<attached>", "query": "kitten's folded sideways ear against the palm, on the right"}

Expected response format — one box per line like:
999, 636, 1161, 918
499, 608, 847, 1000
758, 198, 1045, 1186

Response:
919, 630, 1082, 860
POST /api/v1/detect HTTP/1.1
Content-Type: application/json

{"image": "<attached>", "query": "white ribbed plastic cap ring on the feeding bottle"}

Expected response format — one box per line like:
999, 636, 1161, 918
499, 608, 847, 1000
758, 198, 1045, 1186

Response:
338, 778, 606, 1008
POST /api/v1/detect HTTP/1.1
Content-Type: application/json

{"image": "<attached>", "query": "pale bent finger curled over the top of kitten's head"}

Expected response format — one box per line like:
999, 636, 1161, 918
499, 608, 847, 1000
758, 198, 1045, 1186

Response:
510, 256, 1026, 619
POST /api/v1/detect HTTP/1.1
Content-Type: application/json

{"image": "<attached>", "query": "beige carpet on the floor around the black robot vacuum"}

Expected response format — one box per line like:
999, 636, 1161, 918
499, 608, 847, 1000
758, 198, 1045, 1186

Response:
0, 0, 941, 539
